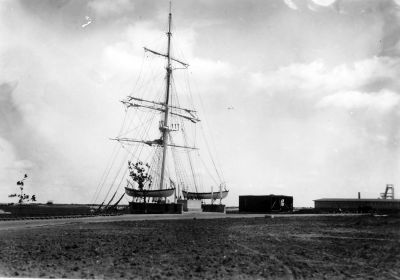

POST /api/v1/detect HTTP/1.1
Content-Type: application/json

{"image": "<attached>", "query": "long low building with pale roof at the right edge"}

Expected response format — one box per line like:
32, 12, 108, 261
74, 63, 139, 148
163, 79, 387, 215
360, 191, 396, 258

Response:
314, 198, 400, 212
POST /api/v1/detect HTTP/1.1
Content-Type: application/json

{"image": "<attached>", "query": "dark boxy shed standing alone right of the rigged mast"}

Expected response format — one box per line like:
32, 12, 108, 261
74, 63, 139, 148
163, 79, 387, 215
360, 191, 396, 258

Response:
239, 194, 293, 213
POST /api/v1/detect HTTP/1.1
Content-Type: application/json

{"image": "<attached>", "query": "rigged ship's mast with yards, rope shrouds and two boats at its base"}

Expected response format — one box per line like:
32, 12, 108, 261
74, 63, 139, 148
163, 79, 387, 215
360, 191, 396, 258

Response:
92, 7, 229, 210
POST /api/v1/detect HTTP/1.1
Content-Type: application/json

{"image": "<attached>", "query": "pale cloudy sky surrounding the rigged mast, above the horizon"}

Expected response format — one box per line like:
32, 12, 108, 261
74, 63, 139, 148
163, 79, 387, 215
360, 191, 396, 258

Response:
0, 0, 400, 206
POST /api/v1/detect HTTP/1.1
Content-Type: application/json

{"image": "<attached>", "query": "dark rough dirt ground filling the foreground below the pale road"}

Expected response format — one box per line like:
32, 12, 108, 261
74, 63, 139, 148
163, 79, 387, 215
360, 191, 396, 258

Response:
0, 216, 400, 279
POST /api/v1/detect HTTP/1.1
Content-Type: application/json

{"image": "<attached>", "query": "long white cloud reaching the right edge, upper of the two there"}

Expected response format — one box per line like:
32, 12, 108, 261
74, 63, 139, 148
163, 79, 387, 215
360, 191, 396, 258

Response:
250, 57, 400, 95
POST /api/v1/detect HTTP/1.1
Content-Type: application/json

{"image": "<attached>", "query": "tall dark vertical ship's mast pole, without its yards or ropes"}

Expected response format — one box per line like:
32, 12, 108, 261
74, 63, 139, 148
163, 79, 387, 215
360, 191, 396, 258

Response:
160, 3, 172, 190
